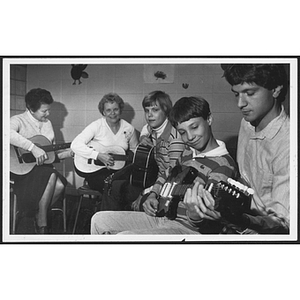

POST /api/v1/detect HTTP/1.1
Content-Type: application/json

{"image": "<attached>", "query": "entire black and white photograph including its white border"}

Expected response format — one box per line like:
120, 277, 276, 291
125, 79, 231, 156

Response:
3, 57, 299, 243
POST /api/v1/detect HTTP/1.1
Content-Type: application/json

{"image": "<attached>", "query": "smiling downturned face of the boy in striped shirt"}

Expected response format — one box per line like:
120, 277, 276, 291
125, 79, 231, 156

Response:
177, 116, 212, 152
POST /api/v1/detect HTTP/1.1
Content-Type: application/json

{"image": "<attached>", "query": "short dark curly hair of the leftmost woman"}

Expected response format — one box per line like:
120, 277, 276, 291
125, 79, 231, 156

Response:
25, 88, 53, 112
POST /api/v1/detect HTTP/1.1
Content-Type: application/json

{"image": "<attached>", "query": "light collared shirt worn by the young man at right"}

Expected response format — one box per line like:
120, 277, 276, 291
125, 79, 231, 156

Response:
237, 108, 290, 223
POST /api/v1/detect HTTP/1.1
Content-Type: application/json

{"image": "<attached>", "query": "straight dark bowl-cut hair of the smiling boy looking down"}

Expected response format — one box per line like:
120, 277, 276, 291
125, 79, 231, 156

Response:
169, 97, 211, 127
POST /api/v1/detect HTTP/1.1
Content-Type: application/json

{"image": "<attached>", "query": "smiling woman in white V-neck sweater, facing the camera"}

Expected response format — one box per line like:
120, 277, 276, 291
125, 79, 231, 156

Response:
71, 93, 138, 192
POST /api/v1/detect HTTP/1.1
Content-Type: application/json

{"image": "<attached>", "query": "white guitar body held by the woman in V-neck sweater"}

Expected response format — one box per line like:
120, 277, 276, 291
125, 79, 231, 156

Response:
74, 141, 128, 174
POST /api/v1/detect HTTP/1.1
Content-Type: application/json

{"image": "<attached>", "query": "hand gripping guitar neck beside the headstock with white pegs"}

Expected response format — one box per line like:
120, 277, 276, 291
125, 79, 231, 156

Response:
183, 182, 221, 221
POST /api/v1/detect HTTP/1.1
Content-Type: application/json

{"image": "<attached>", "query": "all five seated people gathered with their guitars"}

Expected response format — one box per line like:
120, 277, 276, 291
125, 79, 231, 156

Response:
10, 64, 290, 234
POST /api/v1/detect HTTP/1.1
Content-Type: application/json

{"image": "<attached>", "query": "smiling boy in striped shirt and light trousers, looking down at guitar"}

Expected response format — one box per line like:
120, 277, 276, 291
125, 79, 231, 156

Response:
91, 97, 237, 234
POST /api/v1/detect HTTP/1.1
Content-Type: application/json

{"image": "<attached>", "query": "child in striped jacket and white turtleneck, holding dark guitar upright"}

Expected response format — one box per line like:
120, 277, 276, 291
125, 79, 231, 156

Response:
101, 91, 184, 210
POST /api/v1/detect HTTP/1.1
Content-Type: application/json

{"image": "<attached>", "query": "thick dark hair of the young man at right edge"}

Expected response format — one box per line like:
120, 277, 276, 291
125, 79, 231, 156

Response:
222, 64, 288, 102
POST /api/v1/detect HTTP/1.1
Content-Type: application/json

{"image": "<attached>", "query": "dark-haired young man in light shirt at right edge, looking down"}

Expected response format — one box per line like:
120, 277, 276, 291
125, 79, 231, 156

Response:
186, 64, 290, 234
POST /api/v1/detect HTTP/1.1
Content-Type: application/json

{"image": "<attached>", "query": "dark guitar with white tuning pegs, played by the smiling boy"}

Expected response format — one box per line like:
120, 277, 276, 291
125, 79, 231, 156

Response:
157, 166, 254, 220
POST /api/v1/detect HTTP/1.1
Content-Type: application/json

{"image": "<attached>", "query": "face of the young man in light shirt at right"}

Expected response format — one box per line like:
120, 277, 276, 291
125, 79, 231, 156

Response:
231, 83, 281, 126
